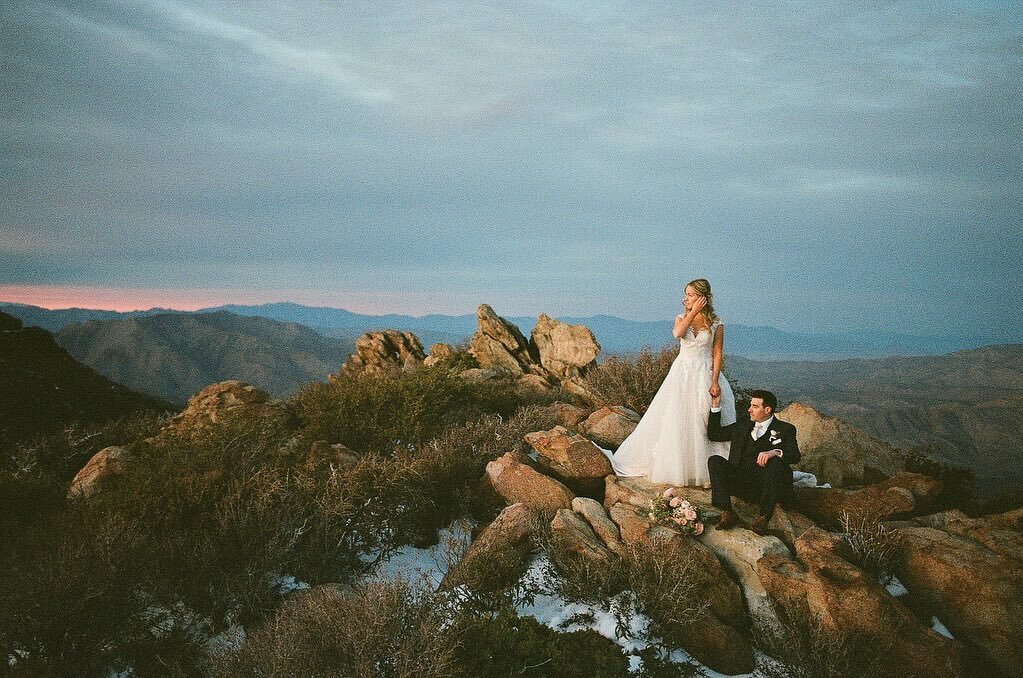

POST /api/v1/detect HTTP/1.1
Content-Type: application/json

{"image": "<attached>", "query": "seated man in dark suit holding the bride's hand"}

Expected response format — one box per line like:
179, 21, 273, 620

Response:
707, 391, 799, 534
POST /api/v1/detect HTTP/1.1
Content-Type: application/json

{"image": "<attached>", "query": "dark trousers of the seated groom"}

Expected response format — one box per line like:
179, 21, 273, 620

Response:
707, 454, 792, 518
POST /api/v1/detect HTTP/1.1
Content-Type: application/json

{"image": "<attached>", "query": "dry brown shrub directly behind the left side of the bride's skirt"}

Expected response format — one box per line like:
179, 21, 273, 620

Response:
585, 346, 678, 414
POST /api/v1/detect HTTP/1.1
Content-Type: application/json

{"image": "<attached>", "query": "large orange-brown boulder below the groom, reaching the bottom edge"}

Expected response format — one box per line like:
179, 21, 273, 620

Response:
757, 529, 963, 676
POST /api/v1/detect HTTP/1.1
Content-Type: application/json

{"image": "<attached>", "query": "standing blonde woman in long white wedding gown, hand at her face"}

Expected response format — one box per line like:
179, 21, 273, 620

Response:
611, 278, 736, 487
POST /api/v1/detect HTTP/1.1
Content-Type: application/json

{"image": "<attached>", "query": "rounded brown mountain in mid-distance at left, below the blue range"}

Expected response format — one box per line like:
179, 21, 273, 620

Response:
56, 312, 353, 403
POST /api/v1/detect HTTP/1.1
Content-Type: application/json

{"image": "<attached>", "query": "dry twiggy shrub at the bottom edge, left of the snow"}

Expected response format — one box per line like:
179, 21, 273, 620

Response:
216, 581, 457, 678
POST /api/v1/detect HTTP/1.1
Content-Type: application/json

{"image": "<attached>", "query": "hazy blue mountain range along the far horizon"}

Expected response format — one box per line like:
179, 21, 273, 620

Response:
0, 302, 1004, 360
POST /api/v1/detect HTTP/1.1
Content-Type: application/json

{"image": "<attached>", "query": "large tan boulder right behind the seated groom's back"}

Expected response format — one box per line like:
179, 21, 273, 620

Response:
779, 403, 905, 487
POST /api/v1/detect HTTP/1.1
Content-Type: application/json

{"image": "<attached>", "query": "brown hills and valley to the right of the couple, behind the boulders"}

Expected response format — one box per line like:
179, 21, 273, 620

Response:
725, 344, 1023, 509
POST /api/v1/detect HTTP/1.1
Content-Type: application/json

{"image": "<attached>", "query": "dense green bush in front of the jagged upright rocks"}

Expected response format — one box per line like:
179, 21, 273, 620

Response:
293, 367, 518, 454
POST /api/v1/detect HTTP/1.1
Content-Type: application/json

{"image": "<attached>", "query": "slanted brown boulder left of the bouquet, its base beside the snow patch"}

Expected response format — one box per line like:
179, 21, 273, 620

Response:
441, 502, 536, 591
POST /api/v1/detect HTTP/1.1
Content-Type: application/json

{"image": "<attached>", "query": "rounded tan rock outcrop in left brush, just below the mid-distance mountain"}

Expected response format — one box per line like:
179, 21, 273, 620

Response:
164, 380, 290, 433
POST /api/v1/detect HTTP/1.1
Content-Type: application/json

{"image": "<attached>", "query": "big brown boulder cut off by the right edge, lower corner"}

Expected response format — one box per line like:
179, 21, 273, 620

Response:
895, 512, 1023, 676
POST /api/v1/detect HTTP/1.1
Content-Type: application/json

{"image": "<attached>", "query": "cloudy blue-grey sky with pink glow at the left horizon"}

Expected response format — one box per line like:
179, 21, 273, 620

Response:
0, 0, 1023, 341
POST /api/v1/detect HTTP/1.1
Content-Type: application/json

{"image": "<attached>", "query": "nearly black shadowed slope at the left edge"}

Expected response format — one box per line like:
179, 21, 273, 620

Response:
0, 313, 175, 447
